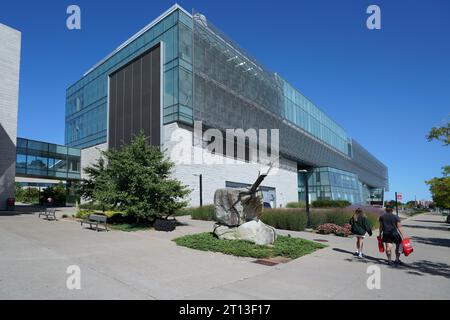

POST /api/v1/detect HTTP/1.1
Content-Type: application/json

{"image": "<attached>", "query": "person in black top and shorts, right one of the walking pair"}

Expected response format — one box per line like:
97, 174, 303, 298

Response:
379, 208, 405, 265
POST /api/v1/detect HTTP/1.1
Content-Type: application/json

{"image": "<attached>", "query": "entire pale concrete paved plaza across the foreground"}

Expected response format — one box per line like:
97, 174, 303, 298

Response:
0, 209, 450, 299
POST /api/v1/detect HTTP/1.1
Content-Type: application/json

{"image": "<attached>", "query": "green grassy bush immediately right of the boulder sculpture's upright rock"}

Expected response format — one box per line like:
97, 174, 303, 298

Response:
260, 209, 307, 231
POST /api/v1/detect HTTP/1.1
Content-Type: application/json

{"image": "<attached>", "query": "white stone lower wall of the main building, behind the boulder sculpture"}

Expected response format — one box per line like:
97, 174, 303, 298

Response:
164, 123, 298, 207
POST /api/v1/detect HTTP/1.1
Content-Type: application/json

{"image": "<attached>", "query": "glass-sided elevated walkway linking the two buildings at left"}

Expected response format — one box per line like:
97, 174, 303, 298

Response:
16, 138, 81, 180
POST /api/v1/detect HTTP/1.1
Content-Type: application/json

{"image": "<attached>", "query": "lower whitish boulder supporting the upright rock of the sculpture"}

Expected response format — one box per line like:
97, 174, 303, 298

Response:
214, 220, 277, 245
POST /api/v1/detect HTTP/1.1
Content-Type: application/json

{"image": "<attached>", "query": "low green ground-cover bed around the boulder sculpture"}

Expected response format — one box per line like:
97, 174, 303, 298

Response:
173, 232, 326, 259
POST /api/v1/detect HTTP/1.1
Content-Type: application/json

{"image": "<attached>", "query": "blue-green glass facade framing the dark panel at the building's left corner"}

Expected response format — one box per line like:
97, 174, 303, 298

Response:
65, 9, 192, 148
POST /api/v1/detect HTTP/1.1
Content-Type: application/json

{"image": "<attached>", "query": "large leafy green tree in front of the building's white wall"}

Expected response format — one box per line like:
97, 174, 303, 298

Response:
81, 132, 189, 221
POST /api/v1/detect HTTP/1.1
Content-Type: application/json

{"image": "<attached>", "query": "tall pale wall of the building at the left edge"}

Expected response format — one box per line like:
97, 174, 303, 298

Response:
0, 23, 21, 210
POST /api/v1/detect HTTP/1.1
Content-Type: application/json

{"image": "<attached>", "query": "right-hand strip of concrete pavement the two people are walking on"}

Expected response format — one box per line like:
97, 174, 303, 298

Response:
189, 214, 450, 300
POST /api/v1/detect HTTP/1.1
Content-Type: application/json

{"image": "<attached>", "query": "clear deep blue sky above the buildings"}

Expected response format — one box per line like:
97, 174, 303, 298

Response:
0, 0, 450, 200
